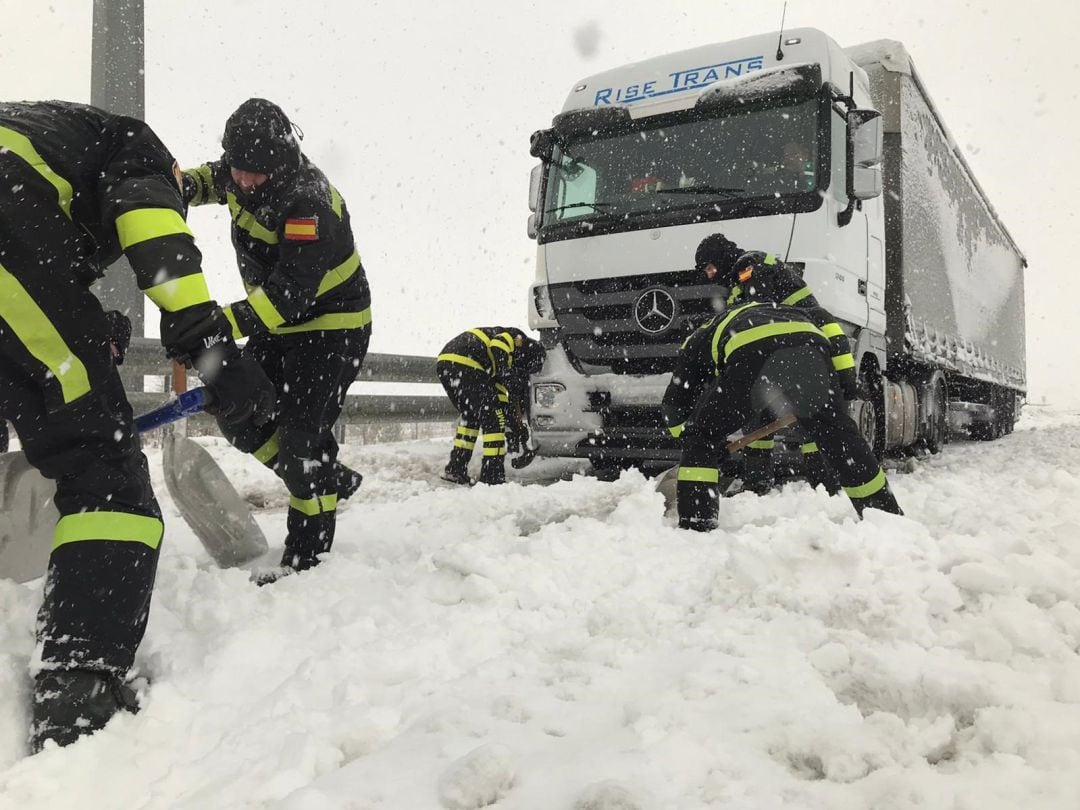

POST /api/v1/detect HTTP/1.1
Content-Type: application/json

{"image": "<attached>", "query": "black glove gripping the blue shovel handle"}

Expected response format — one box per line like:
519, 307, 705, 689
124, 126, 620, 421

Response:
192, 339, 276, 424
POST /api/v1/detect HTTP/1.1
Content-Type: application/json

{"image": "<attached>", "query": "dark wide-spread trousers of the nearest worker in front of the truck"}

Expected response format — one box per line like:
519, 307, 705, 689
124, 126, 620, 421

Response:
677, 342, 901, 529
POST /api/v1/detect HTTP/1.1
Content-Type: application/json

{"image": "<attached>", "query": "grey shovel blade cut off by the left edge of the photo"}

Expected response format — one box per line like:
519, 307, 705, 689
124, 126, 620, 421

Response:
0, 453, 59, 582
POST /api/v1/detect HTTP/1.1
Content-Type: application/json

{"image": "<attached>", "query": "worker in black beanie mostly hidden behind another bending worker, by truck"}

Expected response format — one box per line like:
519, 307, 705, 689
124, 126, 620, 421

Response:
694, 233, 859, 495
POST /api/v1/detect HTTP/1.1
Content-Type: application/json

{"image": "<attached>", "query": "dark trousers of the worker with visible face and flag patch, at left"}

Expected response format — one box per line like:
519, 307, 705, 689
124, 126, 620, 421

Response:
218, 328, 370, 569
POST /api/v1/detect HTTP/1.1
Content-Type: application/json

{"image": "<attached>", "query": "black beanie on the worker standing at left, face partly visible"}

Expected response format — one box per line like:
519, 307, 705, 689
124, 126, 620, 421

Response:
221, 98, 300, 175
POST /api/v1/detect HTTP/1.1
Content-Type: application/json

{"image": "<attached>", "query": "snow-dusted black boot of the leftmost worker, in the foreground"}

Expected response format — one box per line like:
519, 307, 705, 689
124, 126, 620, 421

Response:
30, 670, 138, 754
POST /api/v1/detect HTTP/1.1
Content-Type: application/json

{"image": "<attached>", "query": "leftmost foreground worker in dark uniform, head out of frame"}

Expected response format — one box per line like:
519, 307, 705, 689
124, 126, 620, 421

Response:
0, 102, 273, 752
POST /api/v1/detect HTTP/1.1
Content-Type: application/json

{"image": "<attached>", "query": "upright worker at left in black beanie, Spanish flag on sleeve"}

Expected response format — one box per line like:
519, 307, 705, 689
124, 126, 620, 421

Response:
184, 98, 372, 583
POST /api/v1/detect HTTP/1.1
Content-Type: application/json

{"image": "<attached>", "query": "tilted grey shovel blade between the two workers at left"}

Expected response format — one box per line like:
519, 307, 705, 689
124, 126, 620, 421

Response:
163, 436, 269, 568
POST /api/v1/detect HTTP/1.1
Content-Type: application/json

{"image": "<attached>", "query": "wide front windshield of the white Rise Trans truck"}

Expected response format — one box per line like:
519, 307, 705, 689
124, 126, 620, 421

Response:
541, 98, 827, 230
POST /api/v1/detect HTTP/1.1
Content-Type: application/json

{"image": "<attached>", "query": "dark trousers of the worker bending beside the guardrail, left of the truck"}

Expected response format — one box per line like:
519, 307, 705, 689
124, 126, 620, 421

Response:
435, 360, 507, 484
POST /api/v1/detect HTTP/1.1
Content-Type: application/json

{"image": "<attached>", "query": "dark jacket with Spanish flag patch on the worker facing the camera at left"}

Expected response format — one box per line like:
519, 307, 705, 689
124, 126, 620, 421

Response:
184, 156, 372, 337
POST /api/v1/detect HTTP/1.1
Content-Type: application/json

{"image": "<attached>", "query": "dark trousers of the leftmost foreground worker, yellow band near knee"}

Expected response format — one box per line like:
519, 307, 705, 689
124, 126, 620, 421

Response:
0, 326, 162, 675
